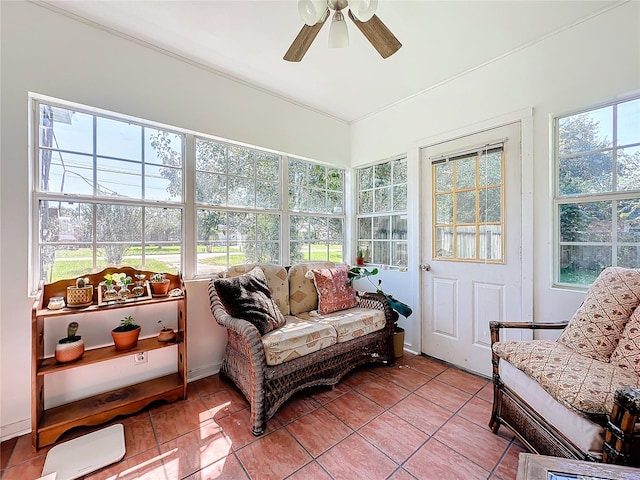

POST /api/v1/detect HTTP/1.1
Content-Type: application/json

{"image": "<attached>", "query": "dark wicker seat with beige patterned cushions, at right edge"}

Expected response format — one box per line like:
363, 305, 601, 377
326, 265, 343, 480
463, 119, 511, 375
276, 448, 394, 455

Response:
490, 267, 640, 464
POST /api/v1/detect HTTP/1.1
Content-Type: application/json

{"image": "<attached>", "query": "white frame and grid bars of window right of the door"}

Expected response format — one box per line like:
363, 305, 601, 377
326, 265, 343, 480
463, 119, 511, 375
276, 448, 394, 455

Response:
550, 95, 640, 291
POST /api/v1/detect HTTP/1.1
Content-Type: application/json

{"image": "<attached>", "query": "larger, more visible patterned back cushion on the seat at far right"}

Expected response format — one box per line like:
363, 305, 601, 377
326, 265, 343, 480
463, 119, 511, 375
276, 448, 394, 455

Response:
558, 267, 640, 361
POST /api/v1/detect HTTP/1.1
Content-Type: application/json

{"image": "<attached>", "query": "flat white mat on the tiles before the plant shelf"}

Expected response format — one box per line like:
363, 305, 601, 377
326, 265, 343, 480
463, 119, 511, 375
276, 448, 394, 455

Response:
42, 423, 126, 480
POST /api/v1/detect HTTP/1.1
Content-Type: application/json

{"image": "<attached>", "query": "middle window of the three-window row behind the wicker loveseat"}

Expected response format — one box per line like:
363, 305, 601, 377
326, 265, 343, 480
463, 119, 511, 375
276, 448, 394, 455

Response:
195, 138, 281, 275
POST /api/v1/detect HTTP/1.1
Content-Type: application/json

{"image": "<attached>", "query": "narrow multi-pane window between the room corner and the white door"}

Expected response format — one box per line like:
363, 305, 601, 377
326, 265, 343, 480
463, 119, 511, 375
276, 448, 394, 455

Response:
357, 158, 407, 267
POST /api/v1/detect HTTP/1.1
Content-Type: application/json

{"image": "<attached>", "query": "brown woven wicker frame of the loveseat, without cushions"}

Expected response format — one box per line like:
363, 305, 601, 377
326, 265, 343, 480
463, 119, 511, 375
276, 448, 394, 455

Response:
209, 274, 395, 436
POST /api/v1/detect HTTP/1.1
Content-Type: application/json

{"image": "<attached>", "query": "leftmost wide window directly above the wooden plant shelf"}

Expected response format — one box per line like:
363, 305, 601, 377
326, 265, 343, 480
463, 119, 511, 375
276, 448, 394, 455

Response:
34, 103, 184, 282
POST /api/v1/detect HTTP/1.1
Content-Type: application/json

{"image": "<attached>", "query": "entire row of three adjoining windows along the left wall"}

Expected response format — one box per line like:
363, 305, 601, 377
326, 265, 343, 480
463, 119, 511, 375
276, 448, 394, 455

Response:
32, 96, 345, 288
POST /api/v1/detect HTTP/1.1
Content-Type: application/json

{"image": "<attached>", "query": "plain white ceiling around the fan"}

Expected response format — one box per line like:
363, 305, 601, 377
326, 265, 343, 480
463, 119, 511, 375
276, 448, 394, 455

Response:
40, 0, 621, 122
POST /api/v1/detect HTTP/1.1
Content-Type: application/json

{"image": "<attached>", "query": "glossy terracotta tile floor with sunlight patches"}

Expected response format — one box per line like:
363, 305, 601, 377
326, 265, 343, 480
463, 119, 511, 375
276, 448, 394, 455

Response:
1, 353, 524, 480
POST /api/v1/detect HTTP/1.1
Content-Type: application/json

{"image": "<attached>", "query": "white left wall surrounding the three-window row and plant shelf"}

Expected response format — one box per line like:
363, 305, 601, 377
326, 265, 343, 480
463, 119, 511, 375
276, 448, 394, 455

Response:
0, 2, 350, 439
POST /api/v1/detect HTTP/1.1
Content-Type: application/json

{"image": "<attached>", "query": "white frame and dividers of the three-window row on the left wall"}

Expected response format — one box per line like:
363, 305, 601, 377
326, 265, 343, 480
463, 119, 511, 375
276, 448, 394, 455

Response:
28, 93, 349, 292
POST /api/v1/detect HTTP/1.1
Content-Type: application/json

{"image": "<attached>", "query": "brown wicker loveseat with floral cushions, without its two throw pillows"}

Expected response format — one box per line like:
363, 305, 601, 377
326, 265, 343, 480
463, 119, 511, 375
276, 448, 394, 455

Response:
209, 262, 395, 435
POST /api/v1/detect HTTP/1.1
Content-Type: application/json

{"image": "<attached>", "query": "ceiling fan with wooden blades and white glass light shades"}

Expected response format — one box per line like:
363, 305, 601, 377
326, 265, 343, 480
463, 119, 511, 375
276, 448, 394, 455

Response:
284, 0, 402, 62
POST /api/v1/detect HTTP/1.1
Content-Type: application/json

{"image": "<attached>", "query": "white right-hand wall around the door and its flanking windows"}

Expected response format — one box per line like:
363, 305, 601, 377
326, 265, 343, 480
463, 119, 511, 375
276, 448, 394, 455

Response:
351, 2, 640, 351
